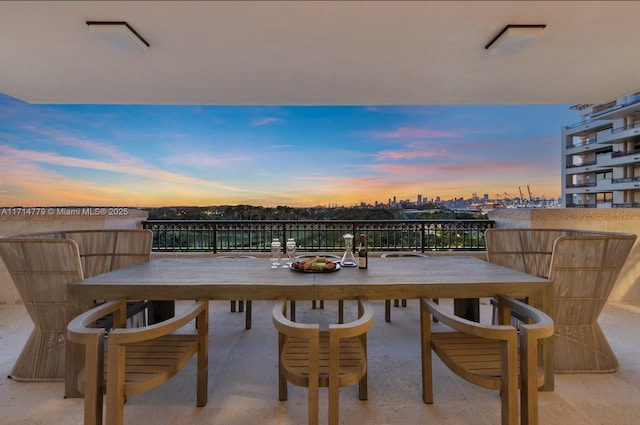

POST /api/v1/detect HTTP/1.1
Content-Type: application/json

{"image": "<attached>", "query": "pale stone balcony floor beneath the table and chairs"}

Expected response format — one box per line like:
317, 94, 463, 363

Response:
0, 300, 640, 425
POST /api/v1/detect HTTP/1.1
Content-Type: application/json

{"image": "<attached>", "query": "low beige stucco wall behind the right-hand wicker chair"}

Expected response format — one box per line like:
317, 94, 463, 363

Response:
488, 208, 640, 303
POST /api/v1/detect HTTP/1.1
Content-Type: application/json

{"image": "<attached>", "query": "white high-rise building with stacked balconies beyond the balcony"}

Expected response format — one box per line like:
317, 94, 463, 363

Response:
561, 91, 640, 208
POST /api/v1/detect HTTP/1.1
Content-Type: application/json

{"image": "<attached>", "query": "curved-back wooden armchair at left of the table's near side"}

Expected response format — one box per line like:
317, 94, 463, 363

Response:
67, 299, 209, 425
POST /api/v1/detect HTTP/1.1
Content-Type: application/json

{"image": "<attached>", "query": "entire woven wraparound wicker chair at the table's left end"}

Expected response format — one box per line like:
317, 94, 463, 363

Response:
0, 229, 152, 381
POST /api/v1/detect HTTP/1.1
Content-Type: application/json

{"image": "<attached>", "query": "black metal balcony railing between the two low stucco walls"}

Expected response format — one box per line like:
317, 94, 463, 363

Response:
143, 220, 494, 253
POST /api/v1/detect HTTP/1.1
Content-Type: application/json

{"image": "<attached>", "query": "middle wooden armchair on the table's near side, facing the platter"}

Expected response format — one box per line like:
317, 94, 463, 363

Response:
273, 299, 373, 425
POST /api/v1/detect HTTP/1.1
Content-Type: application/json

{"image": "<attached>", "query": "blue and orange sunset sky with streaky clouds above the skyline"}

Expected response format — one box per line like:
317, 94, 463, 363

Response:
0, 94, 580, 207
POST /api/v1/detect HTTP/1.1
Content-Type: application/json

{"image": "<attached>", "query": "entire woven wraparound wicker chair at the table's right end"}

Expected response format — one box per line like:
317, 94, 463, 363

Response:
486, 229, 636, 373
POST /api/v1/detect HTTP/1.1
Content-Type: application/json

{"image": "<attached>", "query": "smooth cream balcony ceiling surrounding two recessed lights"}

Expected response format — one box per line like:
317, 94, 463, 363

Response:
0, 1, 640, 105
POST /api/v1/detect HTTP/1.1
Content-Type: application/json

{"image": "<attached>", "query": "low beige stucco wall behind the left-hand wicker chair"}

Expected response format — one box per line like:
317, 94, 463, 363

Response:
0, 207, 149, 304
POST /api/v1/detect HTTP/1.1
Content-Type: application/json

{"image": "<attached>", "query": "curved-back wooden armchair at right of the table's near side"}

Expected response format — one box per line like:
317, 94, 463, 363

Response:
420, 297, 553, 425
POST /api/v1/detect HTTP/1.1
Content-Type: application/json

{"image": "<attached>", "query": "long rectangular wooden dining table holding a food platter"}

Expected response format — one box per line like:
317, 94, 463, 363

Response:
65, 256, 553, 397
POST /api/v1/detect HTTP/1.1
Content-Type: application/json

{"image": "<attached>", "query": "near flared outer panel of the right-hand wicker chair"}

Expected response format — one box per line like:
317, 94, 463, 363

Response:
549, 235, 636, 373
